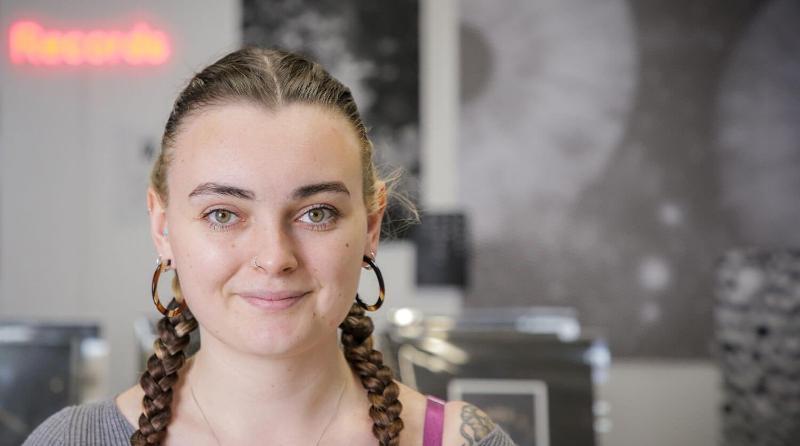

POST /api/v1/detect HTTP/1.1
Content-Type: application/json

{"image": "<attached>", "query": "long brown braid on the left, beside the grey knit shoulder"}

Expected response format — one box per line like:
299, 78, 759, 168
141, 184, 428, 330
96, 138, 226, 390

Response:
131, 299, 197, 446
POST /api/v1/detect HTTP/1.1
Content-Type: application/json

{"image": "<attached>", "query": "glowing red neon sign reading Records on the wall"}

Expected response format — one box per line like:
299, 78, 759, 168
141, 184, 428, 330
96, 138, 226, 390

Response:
8, 20, 170, 66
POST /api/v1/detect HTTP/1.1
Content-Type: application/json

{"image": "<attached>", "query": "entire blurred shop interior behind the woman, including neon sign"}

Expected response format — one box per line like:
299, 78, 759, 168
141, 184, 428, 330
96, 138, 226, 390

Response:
0, 0, 800, 446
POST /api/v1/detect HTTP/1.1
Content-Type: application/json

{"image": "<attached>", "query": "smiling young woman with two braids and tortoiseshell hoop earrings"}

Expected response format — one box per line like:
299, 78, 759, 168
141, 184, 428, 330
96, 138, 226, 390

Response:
25, 48, 512, 446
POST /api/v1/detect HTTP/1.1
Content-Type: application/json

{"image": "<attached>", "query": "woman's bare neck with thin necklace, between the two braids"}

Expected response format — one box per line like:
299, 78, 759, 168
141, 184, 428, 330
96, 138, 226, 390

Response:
182, 335, 363, 444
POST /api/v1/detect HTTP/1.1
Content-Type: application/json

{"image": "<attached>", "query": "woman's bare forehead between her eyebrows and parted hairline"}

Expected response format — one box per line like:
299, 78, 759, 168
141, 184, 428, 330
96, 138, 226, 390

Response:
167, 103, 362, 201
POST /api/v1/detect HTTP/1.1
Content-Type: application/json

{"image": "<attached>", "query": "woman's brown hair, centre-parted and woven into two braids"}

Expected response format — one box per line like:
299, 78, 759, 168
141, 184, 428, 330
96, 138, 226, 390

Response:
131, 48, 418, 446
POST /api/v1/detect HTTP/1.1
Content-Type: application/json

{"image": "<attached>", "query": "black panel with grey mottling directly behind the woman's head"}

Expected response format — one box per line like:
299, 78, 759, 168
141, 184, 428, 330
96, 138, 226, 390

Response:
242, 0, 420, 237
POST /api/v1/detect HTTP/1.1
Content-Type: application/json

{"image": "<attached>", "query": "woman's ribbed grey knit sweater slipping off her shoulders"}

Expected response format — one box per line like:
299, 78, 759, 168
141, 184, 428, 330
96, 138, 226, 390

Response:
22, 400, 515, 446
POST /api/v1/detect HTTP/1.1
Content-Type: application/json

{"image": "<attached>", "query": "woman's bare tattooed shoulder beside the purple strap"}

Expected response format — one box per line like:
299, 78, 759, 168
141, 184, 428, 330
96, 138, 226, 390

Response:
442, 401, 514, 446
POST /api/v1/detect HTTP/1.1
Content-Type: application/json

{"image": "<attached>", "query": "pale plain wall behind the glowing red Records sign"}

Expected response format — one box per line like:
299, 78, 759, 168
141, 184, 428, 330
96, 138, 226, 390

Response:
0, 0, 241, 392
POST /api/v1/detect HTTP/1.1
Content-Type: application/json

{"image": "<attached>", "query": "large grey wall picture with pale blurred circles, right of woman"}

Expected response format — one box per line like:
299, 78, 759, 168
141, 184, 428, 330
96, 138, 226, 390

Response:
458, 0, 800, 358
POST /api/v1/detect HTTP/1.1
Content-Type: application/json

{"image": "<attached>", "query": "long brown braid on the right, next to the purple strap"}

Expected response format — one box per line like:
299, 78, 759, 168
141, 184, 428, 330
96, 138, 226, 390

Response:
339, 303, 403, 446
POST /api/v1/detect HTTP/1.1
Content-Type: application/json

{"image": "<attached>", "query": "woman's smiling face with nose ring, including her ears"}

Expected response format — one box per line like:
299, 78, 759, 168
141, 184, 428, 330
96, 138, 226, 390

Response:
148, 103, 382, 355
